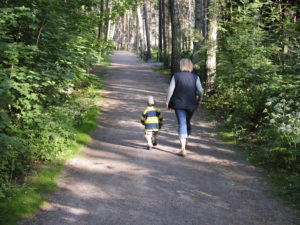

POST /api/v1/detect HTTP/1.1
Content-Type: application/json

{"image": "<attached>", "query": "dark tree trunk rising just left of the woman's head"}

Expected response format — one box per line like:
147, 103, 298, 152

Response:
169, 0, 181, 75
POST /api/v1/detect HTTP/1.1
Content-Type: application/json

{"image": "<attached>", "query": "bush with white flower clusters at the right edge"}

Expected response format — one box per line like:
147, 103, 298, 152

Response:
260, 94, 300, 172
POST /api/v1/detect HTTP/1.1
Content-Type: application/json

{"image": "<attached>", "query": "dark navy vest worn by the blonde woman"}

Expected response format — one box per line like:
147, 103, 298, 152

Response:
169, 72, 198, 110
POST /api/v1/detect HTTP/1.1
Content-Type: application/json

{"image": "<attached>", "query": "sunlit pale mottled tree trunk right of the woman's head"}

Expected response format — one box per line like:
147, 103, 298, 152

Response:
206, 0, 218, 93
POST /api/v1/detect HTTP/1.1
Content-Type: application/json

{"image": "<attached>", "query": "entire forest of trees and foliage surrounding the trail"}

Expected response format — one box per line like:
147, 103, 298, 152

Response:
0, 0, 300, 209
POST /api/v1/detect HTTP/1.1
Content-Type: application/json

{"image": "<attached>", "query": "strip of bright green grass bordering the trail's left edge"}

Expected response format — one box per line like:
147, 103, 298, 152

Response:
0, 76, 105, 225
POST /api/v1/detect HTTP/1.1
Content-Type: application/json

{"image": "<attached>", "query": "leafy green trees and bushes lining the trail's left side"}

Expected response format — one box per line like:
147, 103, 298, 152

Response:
0, 0, 112, 199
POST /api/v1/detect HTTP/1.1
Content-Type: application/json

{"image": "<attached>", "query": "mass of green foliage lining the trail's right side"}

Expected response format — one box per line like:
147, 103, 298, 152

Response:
200, 0, 300, 202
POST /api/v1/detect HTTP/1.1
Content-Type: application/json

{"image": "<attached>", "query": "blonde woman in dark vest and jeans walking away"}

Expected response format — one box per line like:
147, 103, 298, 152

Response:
166, 59, 203, 156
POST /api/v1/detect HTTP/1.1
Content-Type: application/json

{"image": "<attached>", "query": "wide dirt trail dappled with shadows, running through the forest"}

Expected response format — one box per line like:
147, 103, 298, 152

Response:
20, 52, 300, 225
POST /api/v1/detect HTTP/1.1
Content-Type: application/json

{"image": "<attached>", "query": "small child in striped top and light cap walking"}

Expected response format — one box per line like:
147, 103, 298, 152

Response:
141, 95, 163, 150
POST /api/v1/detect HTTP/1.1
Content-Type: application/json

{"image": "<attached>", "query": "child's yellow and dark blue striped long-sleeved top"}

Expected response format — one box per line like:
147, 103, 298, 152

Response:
141, 106, 163, 131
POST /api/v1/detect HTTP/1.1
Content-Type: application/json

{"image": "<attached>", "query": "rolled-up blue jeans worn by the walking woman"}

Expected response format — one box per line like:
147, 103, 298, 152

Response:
175, 109, 194, 138
